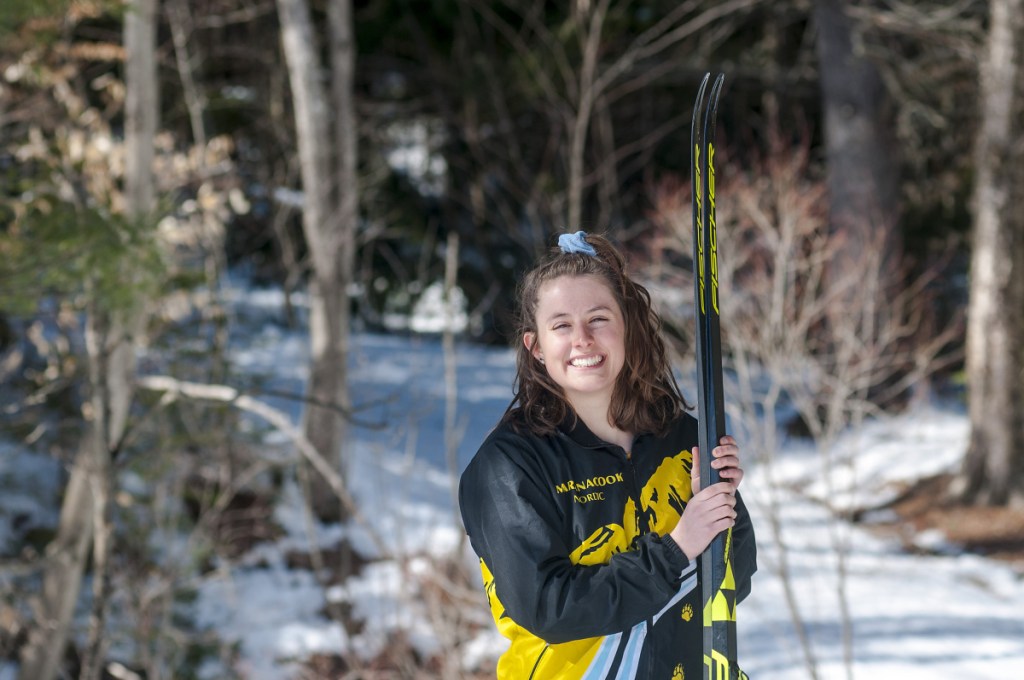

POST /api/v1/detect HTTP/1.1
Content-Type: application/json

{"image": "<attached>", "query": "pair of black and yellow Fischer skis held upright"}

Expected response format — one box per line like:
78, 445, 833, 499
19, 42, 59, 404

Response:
690, 74, 748, 680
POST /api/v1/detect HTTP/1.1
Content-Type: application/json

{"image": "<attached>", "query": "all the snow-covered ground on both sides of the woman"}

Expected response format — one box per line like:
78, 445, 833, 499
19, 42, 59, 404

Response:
0, 284, 1024, 680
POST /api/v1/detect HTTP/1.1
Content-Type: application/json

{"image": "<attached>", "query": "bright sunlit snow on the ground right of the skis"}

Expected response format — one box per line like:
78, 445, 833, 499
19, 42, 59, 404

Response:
738, 409, 1024, 680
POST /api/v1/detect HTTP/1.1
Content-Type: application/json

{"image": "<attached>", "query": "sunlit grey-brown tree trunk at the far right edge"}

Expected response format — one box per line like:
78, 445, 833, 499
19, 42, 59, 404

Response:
961, 0, 1024, 505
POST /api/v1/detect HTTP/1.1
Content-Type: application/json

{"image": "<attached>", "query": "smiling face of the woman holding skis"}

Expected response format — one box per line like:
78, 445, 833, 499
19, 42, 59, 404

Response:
523, 275, 626, 411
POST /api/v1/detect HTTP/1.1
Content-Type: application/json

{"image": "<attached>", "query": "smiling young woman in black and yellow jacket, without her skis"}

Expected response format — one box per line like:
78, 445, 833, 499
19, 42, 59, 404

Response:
459, 231, 756, 680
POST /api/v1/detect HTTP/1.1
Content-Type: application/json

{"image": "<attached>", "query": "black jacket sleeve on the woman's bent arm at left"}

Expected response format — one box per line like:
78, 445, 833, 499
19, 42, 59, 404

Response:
459, 439, 689, 643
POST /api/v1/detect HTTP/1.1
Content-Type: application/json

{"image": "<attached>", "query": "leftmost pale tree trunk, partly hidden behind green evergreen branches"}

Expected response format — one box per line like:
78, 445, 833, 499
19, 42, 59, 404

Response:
18, 0, 159, 680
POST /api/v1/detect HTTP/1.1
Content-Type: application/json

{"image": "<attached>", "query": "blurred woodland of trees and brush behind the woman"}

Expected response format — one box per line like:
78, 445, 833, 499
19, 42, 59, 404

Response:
0, 0, 1024, 679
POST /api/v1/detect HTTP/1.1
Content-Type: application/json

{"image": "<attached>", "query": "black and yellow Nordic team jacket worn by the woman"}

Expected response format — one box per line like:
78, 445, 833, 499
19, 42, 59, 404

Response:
459, 415, 757, 680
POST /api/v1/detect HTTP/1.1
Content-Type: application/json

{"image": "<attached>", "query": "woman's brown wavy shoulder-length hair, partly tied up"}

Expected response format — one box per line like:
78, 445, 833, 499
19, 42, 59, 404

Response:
502, 235, 690, 434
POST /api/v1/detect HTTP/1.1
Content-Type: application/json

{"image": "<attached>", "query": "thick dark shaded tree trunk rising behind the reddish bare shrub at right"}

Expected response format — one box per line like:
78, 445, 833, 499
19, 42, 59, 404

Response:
814, 0, 899, 271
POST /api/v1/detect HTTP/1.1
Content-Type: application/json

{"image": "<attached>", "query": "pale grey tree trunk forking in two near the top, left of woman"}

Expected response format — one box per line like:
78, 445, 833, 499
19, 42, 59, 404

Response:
278, 0, 358, 518
